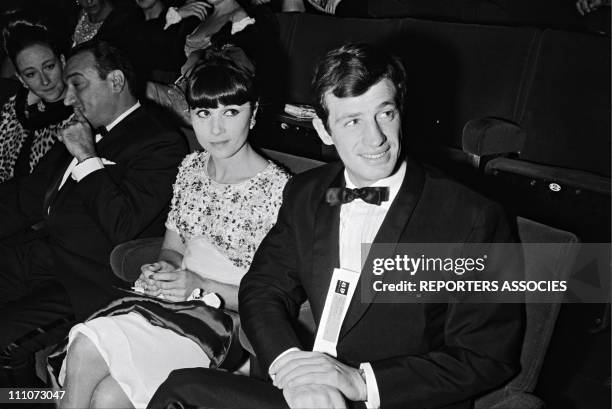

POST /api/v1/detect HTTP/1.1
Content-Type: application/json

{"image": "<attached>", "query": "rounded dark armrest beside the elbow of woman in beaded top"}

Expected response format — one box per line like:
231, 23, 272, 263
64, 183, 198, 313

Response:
110, 237, 164, 282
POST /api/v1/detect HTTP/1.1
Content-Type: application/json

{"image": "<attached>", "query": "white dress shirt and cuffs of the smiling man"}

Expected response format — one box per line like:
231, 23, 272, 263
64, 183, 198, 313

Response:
270, 162, 406, 409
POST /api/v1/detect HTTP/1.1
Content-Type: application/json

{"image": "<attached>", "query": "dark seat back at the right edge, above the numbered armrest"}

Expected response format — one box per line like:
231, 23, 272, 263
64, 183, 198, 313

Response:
518, 30, 611, 177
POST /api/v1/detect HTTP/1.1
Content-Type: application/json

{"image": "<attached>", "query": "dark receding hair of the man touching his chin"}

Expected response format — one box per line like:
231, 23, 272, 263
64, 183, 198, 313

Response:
68, 39, 136, 95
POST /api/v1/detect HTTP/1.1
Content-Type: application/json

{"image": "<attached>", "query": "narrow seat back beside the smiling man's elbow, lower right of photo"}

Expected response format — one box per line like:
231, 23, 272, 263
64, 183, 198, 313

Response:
476, 217, 579, 409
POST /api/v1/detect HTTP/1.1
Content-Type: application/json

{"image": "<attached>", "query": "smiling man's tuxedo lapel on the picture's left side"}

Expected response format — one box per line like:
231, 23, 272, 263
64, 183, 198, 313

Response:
311, 168, 344, 322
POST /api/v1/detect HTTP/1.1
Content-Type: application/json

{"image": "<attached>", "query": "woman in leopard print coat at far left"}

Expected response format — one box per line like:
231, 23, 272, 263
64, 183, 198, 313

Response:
0, 15, 72, 182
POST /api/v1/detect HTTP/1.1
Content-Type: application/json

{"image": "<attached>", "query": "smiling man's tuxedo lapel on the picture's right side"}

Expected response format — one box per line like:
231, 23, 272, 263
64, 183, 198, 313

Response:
339, 159, 424, 340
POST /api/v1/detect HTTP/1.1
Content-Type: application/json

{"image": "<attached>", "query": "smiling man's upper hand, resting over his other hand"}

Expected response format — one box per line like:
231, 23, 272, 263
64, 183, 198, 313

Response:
269, 351, 367, 400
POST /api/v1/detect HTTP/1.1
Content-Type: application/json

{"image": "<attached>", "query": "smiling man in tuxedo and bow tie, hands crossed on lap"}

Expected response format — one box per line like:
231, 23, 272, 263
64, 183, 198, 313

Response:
150, 45, 523, 409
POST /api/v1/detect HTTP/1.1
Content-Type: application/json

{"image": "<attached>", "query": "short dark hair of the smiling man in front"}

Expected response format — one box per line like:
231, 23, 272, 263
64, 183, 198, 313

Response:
312, 44, 406, 127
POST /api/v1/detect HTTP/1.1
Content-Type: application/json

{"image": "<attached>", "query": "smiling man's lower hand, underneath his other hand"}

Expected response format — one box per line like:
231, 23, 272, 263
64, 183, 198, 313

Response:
283, 385, 346, 409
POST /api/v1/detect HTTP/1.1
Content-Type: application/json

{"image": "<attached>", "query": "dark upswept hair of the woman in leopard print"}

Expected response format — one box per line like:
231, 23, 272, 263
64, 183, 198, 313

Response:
2, 10, 66, 64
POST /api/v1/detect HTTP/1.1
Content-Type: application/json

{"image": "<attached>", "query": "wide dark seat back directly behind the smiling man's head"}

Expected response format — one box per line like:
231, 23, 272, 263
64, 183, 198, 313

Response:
278, 14, 541, 148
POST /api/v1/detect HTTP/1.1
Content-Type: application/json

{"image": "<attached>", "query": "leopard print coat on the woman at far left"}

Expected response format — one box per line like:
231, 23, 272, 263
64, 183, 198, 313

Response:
0, 95, 69, 183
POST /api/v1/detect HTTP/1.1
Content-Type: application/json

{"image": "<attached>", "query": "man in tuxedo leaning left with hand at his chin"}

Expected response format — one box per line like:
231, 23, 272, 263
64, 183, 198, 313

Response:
0, 41, 187, 380
